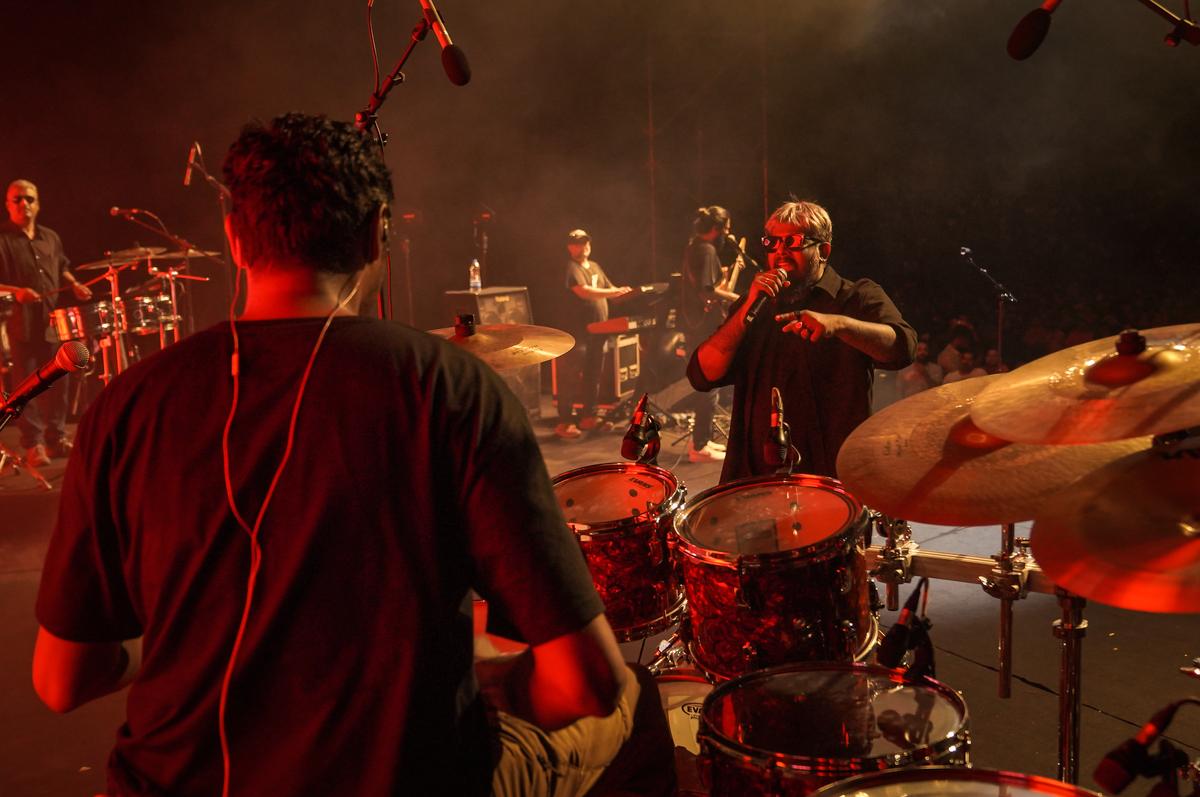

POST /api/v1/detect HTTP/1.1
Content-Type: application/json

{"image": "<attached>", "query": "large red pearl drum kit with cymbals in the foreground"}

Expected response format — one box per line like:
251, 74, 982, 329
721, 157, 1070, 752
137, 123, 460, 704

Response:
438, 324, 1200, 797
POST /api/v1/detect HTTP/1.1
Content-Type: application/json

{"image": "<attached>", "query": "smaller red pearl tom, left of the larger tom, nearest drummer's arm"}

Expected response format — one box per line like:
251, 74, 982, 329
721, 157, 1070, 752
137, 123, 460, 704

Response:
553, 462, 688, 642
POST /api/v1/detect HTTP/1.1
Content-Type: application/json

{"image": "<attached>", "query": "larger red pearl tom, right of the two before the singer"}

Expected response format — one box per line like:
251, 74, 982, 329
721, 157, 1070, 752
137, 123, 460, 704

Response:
672, 474, 878, 678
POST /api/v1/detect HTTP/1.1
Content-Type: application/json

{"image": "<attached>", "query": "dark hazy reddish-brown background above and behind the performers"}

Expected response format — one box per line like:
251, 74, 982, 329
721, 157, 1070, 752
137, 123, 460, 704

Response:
0, 0, 1200, 355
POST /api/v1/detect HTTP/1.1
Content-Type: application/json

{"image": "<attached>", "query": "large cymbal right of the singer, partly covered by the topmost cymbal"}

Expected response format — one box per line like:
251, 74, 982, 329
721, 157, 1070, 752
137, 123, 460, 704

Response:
838, 374, 1150, 526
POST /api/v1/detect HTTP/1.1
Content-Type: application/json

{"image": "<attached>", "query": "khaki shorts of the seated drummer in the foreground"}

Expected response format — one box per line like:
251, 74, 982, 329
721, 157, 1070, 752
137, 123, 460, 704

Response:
492, 672, 641, 797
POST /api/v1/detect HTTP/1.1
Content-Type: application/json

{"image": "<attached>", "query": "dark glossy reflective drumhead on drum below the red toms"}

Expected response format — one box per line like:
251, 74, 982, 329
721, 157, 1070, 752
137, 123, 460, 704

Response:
703, 665, 966, 760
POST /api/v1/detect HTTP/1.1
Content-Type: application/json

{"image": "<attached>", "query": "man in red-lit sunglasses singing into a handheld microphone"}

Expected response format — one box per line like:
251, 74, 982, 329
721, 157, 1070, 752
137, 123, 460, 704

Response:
688, 199, 917, 483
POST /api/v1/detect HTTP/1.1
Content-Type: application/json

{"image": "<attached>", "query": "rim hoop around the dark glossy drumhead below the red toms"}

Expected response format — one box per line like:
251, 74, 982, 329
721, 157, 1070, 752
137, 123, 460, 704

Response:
700, 661, 970, 774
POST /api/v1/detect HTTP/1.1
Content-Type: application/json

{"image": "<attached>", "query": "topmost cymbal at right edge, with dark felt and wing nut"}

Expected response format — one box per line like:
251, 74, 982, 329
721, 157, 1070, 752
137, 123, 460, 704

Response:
971, 324, 1200, 443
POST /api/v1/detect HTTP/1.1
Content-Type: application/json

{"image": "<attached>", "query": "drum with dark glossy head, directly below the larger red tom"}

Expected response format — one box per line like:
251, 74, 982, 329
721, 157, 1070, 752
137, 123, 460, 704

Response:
700, 664, 971, 797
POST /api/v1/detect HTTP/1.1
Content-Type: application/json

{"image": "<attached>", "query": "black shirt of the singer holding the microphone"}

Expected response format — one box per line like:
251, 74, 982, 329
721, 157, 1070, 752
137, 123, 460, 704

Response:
688, 265, 917, 483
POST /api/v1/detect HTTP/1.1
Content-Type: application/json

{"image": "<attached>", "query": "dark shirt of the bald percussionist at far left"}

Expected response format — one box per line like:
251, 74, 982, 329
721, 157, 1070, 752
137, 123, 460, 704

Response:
0, 220, 71, 342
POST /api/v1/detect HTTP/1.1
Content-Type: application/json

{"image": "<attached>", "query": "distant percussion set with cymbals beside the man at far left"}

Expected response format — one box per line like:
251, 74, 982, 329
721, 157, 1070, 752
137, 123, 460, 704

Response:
59, 246, 218, 385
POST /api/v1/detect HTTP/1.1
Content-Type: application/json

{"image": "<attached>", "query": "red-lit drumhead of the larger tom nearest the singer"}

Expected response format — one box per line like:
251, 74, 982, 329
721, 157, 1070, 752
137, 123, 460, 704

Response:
676, 477, 863, 556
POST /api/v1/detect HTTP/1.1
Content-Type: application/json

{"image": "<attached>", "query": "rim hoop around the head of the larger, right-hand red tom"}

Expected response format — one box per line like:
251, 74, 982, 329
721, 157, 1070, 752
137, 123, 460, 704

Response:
671, 473, 870, 567
